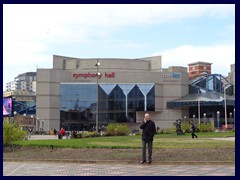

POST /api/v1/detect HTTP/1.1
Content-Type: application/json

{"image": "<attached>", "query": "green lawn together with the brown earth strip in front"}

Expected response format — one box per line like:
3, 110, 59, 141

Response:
3, 132, 235, 163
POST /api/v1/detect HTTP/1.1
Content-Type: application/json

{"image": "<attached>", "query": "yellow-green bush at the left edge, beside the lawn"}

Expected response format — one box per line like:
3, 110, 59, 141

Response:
3, 122, 27, 145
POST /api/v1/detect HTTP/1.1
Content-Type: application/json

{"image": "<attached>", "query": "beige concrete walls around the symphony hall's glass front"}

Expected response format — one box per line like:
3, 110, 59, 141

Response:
36, 55, 188, 131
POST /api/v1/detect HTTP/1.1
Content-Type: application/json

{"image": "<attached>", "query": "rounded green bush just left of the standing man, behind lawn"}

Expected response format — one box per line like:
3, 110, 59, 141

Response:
105, 123, 131, 136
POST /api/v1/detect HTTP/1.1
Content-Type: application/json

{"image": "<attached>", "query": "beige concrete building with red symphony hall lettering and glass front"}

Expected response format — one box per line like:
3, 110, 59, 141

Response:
36, 55, 189, 131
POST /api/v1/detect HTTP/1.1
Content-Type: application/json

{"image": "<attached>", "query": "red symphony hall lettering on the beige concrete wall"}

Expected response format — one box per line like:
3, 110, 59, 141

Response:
72, 72, 115, 79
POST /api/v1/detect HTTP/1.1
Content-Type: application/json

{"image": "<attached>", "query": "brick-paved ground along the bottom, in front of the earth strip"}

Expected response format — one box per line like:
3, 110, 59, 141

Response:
3, 162, 235, 176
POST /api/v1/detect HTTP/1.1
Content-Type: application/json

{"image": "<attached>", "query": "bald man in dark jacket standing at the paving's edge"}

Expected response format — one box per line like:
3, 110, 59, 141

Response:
140, 113, 156, 164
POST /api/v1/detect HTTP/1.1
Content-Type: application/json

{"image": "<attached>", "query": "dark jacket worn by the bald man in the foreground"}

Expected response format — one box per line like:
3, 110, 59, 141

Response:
140, 120, 156, 141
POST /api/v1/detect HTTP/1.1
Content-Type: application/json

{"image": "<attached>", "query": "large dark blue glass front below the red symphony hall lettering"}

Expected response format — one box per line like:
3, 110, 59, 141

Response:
60, 83, 155, 130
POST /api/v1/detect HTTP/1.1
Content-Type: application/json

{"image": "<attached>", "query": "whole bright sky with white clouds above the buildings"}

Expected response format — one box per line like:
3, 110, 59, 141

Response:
3, 4, 235, 90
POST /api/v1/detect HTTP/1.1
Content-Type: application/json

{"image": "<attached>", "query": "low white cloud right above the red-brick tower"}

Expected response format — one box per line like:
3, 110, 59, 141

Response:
153, 44, 235, 75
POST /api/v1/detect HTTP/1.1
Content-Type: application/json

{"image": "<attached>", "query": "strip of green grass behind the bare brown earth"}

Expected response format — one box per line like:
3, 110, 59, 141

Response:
14, 132, 235, 149
